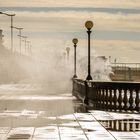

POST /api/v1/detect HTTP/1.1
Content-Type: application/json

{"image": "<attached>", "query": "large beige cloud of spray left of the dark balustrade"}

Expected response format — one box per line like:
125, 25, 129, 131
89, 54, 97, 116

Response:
0, 42, 72, 90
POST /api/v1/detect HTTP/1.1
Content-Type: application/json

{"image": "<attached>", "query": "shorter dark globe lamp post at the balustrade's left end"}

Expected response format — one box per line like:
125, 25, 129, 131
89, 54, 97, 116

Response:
72, 38, 78, 78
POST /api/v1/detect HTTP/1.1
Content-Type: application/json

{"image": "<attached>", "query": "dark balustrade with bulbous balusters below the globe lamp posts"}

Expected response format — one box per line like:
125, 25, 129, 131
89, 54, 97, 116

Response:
73, 79, 140, 112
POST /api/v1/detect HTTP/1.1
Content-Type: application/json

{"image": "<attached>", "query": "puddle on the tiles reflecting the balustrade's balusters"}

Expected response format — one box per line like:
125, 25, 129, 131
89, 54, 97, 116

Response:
99, 119, 140, 132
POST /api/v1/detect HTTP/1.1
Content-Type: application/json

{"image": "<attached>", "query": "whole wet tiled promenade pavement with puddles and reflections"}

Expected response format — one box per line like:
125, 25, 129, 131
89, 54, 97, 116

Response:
0, 84, 140, 140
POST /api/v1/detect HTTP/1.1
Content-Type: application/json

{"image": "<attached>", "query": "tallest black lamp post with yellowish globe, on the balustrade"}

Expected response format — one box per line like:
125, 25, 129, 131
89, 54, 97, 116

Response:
85, 21, 93, 80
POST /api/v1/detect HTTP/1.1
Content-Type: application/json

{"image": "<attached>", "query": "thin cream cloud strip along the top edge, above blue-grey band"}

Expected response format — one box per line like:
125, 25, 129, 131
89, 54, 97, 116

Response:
0, 0, 140, 8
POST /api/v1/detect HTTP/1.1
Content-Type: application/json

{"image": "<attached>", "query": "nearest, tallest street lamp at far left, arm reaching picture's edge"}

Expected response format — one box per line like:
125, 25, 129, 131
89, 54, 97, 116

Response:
0, 12, 15, 52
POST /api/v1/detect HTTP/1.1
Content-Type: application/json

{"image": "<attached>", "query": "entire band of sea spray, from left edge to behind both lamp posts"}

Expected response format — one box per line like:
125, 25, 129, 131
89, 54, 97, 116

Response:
0, 43, 111, 87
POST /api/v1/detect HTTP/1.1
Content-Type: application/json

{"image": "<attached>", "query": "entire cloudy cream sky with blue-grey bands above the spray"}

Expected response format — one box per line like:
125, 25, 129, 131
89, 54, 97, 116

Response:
0, 0, 140, 63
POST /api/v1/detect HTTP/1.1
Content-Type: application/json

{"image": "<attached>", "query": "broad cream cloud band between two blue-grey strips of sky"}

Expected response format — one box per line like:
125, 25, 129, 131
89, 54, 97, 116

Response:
1, 11, 140, 32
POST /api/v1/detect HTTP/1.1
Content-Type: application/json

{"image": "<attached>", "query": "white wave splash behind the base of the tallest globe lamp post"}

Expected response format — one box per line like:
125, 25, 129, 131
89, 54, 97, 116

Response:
78, 56, 112, 81
